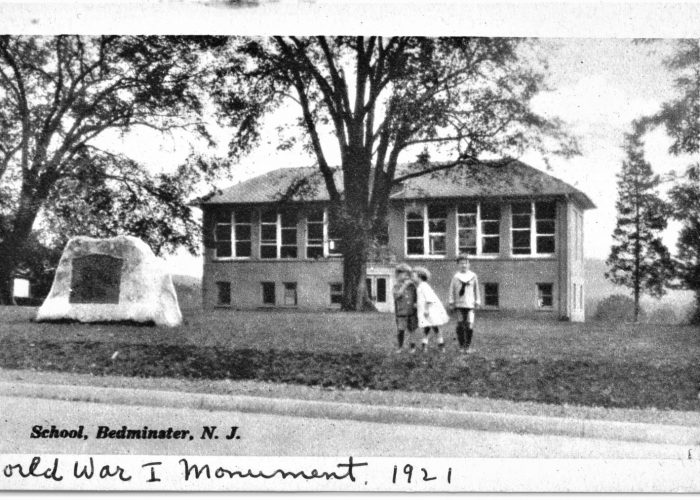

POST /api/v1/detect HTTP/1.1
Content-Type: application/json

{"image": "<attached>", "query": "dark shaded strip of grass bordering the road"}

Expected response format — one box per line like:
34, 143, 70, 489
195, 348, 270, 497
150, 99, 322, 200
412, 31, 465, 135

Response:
0, 338, 700, 411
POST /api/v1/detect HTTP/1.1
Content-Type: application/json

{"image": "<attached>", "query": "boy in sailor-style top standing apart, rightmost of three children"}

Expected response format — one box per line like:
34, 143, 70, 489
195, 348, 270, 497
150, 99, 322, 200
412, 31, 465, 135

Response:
449, 255, 481, 352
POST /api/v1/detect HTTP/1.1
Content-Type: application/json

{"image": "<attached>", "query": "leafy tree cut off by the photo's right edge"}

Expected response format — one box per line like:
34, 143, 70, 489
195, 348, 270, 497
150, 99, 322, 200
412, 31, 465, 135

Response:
638, 39, 700, 322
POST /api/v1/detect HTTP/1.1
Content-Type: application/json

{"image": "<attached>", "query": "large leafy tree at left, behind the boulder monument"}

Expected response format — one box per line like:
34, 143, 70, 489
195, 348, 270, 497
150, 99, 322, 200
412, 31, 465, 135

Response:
0, 36, 220, 304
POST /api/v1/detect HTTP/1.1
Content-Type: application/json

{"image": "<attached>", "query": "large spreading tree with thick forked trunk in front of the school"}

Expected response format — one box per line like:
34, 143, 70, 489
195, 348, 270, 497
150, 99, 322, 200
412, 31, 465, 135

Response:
215, 36, 576, 310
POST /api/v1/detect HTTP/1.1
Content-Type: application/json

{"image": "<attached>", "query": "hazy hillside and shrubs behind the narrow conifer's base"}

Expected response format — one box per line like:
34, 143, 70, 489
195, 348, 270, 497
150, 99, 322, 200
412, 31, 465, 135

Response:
585, 259, 693, 320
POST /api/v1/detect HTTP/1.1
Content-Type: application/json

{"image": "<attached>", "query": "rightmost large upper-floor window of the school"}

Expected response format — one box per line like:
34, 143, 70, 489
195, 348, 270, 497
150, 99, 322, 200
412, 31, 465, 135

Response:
512, 201, 557, 255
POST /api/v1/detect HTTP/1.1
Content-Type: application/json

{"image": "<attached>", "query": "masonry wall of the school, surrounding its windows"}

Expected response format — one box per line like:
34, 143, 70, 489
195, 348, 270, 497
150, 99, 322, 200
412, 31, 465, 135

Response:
203, 195, 585, 321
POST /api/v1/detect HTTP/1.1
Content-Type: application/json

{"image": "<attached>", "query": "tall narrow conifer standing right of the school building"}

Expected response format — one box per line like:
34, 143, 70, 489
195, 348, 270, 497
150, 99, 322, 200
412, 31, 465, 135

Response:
605, 134, 673, 322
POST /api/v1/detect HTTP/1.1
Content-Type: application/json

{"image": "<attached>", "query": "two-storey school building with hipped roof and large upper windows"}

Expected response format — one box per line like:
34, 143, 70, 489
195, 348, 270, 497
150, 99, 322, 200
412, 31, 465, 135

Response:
199, 160, 595, 321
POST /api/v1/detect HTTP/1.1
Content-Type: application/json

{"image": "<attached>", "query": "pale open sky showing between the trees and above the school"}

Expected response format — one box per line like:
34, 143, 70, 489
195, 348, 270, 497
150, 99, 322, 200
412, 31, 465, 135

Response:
97, 38, 688, 275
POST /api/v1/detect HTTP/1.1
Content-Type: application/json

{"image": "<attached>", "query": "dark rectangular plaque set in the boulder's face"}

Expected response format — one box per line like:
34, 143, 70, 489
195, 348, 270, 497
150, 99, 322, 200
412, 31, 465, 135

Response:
69, 254, 123, 304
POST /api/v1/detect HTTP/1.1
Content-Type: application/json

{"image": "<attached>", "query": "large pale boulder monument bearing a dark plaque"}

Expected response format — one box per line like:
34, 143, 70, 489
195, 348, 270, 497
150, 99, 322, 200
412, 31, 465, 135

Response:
36, 236, 182, 326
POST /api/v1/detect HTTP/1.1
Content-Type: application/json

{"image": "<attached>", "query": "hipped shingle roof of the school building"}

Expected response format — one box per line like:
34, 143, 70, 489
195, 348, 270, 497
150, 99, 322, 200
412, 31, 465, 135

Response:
198, 160, 595, 209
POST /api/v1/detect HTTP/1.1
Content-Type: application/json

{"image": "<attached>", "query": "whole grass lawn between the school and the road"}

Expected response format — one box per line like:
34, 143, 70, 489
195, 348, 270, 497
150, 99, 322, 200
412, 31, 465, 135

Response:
0, 307, 700, 411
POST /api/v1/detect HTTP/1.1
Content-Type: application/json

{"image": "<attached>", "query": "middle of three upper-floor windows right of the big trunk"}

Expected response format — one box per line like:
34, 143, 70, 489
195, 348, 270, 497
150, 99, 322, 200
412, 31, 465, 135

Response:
457, 203, 501, 255
